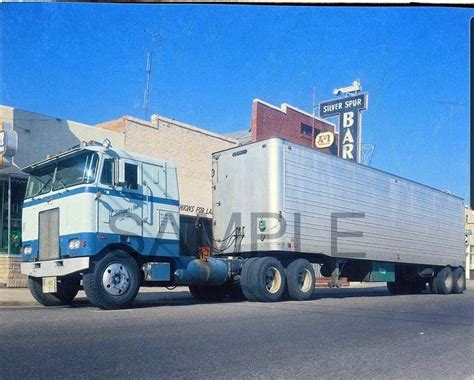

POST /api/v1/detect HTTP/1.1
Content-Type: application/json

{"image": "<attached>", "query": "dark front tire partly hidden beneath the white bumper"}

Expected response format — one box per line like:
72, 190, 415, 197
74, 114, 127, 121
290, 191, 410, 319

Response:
28, 275, 81, 306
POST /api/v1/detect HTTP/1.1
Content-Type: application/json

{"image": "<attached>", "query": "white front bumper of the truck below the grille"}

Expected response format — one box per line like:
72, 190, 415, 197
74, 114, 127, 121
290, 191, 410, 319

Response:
21, 257, 89, 277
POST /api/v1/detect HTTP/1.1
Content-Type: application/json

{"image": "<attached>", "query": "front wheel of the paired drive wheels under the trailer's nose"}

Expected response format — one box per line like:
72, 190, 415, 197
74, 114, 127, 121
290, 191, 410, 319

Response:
248, 257, 286, 302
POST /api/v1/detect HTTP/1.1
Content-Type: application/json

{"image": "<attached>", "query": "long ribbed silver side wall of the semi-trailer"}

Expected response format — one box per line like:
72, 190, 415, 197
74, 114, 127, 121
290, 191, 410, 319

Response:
284, 144, 464, 265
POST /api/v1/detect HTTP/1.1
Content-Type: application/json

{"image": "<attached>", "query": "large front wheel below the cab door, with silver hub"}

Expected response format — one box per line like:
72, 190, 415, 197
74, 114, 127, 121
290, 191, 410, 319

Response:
82, 250, 140, 310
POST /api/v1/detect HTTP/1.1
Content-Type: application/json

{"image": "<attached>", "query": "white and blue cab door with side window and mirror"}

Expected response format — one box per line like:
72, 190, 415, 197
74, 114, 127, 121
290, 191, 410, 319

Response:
98, 158, 145, 236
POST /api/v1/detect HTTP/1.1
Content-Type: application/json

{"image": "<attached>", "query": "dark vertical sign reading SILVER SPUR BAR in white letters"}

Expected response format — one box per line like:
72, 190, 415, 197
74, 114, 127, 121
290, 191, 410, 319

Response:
319, 93, 368, 162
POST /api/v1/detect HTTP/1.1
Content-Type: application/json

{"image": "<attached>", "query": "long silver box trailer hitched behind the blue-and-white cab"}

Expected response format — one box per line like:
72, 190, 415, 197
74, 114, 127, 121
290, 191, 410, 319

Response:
212, 139, 465, 302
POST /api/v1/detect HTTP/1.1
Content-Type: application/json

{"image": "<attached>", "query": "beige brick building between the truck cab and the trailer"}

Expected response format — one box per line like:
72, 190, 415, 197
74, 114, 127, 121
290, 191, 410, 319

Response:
97, 115, 238, 218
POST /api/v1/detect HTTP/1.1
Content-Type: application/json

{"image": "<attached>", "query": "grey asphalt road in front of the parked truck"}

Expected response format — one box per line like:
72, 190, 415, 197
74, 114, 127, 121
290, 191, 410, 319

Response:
0, 288, 474, 379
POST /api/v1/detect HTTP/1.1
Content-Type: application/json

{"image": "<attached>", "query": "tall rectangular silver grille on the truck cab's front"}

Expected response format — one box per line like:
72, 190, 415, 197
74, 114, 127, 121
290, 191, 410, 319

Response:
39, 208, 59, 260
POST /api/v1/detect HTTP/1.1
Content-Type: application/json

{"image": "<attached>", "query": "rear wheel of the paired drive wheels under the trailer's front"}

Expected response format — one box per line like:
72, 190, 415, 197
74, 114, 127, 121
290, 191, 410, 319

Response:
286, 259, 316, 301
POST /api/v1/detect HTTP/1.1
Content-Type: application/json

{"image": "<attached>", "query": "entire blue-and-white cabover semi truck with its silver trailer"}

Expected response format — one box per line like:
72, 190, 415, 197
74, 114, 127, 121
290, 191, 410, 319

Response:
21, 138, 465, 309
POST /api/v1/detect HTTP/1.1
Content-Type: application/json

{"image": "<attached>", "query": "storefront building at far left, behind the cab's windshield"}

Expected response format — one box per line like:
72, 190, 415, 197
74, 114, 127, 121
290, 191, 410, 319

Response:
0, 105, 124, 287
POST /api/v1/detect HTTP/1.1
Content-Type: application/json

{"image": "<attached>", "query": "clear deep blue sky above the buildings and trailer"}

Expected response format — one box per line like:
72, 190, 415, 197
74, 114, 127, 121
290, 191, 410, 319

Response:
0, 3, 474, 203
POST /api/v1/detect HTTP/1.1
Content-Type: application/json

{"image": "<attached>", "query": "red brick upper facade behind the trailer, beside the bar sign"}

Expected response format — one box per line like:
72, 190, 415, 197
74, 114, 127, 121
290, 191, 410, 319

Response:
251, 99, 337, 154
